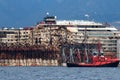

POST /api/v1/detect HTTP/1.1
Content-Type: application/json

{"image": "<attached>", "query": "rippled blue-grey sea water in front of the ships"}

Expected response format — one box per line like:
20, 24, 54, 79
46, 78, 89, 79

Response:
0, 67, 120, 80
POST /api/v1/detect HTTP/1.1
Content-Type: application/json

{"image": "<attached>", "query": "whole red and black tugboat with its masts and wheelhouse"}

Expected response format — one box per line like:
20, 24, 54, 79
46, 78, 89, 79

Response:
67, 43, 119, 67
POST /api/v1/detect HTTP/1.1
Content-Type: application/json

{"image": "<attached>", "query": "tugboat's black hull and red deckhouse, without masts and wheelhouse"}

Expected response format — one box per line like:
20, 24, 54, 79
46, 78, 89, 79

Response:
67, 53, 119, 67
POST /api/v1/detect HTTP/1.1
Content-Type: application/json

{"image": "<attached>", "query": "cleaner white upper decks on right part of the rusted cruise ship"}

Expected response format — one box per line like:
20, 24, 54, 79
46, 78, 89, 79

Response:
56, 20, 120, 56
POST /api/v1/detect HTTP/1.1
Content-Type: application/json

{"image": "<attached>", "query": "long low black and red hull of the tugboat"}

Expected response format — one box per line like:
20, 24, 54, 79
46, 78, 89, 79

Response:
67, 61, 119, 67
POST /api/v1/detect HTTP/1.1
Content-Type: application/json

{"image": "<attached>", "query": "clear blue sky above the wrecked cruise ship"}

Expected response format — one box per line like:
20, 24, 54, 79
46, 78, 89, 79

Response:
0, 0, 120, 27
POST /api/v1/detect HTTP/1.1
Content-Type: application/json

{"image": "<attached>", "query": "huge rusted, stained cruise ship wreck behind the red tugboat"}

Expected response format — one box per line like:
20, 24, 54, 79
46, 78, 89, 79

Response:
0, 15, 120, 66
